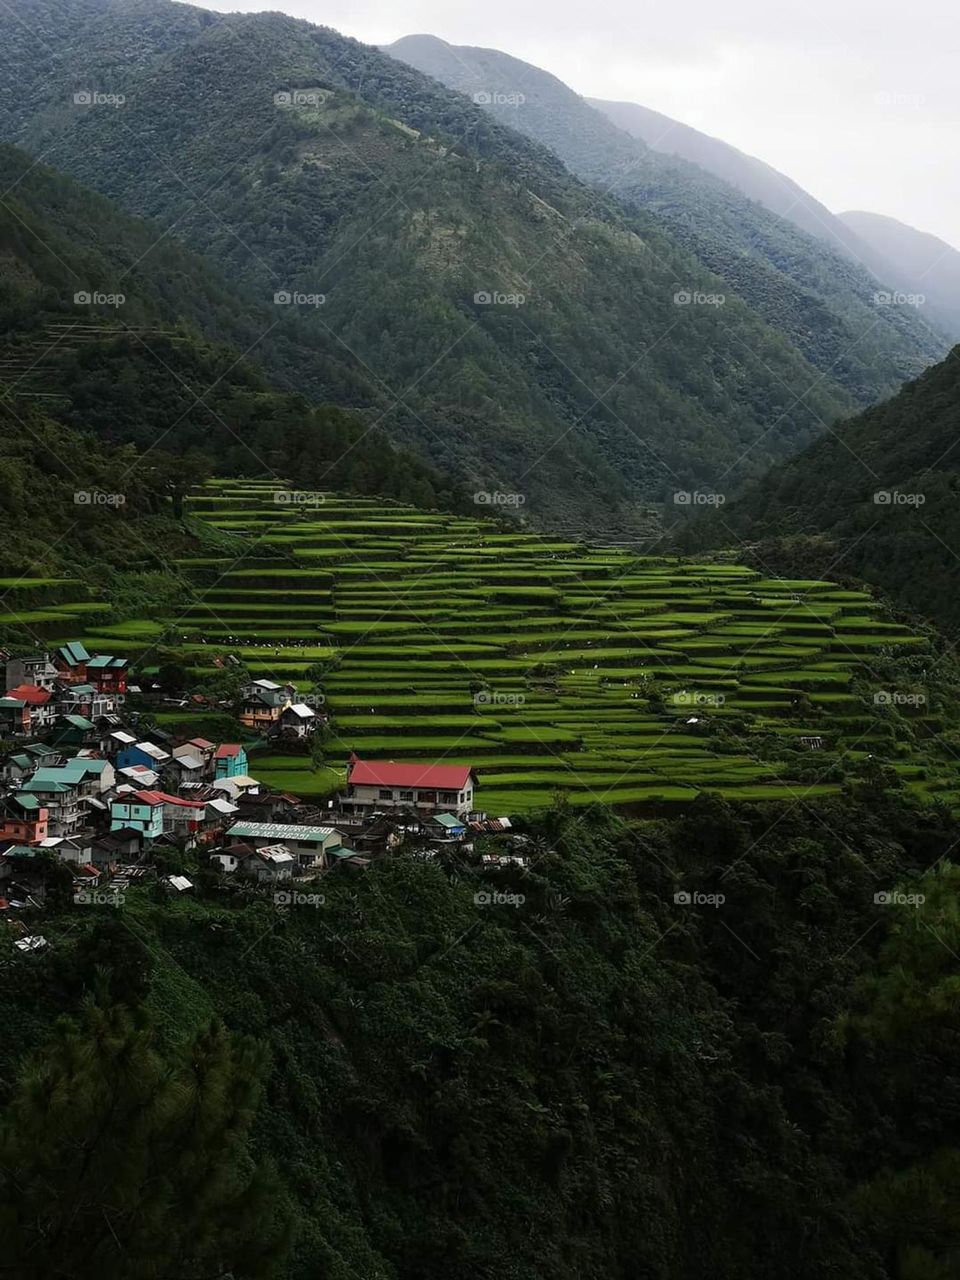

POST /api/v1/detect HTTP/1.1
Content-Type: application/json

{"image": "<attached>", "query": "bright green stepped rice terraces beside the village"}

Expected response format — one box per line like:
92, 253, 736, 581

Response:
75, 481, 955, 813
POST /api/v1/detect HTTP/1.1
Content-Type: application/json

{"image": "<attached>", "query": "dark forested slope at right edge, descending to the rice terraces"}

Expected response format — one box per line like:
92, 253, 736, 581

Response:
714, 347, 960, 634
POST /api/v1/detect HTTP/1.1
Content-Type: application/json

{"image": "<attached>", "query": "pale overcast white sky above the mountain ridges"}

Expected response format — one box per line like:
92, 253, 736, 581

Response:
200, 0, 960, 248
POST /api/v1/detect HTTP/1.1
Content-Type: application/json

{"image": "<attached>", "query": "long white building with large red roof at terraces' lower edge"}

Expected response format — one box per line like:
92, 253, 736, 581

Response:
342, 755, 476, 818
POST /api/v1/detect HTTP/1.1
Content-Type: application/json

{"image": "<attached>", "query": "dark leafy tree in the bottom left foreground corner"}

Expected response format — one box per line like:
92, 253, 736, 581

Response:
0, 1000, 288, 1280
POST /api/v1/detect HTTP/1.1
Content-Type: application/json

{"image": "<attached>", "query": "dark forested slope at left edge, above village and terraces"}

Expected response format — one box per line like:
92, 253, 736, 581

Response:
0, 147, 463, 508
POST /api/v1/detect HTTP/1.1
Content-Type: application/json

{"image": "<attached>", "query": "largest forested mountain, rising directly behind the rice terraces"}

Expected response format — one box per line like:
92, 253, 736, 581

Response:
0, 0, 947, 529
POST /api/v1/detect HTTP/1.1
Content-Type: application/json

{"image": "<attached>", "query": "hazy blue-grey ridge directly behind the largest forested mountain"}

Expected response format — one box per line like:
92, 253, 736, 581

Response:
389, 36, 947, 404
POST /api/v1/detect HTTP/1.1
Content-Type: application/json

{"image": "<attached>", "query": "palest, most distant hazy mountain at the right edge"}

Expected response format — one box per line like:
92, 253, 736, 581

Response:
838, 212, 960, 338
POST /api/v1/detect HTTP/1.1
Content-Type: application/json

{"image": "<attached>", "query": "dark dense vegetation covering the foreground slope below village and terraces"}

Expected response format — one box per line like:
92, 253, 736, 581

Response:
0, 794, 960, 1280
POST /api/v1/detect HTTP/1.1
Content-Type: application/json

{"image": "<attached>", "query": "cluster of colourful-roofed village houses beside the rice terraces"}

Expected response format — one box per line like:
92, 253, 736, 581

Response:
0, 641, 526, 951
